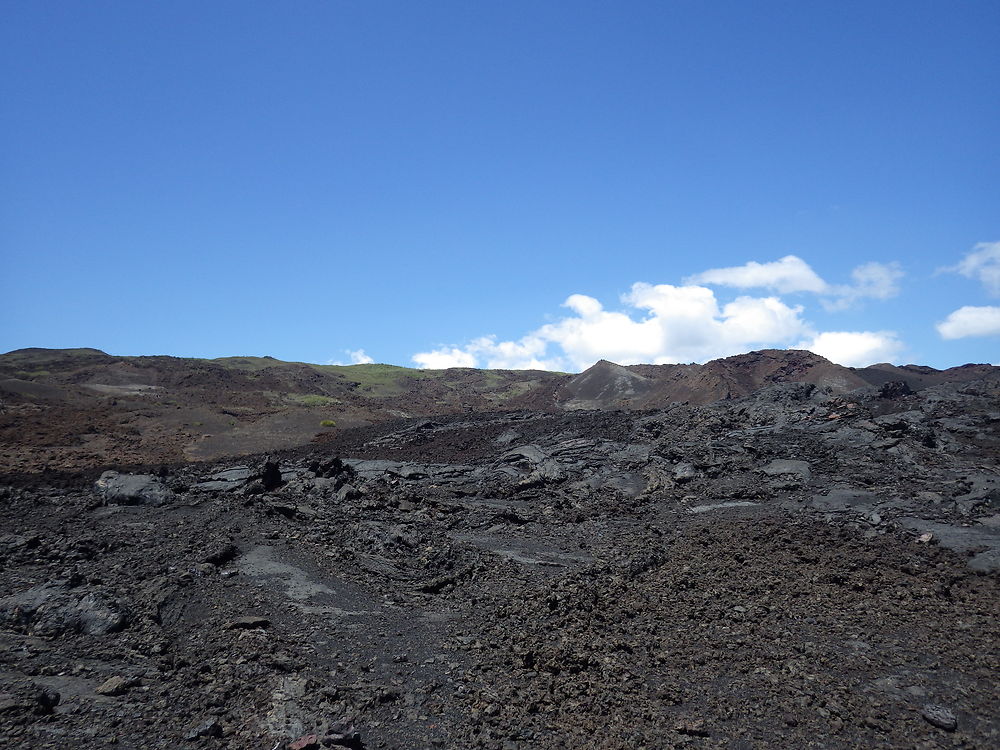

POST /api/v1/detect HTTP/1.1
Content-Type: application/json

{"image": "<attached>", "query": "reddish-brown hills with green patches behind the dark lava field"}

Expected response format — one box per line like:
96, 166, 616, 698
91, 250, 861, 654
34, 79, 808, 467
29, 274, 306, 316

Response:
0, 349, 1000, 471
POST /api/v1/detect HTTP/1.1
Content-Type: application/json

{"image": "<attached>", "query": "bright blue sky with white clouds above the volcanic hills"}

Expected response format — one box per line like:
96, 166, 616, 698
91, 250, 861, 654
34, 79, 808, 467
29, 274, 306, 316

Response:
0, 0, 1000, 370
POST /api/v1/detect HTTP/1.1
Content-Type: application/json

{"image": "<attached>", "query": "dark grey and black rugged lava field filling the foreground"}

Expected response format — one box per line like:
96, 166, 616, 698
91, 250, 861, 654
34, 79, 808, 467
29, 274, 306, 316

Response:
0, 374, 1000, 750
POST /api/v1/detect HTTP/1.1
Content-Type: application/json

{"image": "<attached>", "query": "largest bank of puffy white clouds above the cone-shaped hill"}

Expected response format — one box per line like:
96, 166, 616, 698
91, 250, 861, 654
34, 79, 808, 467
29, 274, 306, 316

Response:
413, 255, 916, 370
